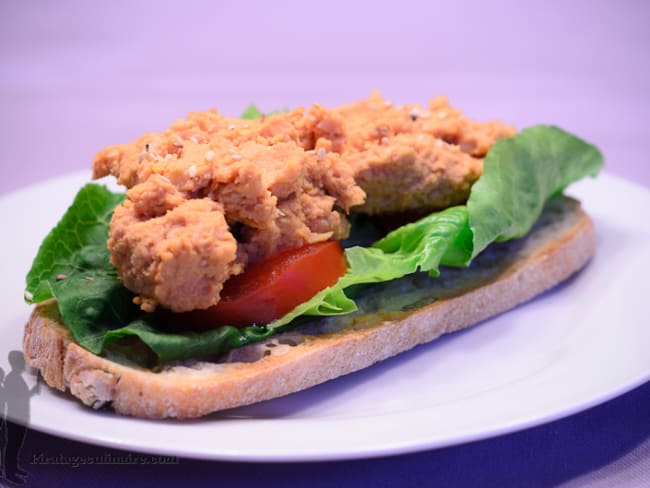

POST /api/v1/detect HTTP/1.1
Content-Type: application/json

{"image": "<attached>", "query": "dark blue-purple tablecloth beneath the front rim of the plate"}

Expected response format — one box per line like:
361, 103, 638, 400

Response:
5, 383, 650, 488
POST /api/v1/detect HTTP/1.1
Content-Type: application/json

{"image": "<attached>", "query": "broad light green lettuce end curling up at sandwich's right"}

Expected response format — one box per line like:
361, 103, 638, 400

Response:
467, 125, 603, 257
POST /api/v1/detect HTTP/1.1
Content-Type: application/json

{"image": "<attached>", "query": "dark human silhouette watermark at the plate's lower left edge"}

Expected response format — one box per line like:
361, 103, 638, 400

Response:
0, 351, 40, 485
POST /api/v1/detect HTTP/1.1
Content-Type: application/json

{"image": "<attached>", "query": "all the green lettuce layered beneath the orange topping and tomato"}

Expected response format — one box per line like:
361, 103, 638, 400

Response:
26, 125, 603, 362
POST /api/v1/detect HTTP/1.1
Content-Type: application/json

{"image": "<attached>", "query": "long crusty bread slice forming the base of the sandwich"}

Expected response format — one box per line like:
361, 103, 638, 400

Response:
24, 197, 595, 418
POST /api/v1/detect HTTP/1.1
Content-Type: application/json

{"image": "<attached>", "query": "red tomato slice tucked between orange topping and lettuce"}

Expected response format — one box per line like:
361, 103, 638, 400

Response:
168, 241, 347, 330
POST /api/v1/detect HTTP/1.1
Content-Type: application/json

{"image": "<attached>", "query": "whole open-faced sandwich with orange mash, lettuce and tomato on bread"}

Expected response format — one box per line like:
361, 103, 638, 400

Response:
24, 94, 602, 418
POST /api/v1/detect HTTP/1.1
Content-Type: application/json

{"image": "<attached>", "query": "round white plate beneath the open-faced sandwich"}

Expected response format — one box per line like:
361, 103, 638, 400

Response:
0, 172, 650, 461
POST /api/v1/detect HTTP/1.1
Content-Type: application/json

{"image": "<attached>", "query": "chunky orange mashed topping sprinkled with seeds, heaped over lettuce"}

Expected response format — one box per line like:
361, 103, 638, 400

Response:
93, 93, 514, 311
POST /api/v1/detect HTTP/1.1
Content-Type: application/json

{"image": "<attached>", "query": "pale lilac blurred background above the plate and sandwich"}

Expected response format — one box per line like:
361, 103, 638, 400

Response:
0, 0, 650, 191
